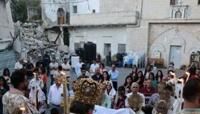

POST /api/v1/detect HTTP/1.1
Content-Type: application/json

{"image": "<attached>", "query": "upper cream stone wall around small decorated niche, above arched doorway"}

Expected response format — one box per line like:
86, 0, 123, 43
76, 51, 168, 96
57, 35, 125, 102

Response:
142, 0, 200, 19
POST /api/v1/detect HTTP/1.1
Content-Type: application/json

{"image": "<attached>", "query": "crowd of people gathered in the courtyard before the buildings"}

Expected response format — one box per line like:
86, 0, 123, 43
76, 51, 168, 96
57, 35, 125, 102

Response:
0, 54, 200, 114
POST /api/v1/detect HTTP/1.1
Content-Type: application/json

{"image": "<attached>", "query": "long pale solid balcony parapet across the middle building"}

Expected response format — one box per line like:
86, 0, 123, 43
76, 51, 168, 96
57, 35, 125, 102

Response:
70, 11, 138, 26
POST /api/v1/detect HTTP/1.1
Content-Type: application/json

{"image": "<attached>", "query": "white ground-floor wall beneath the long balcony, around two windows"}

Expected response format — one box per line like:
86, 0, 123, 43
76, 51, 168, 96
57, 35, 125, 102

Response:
70, 27, 128, 57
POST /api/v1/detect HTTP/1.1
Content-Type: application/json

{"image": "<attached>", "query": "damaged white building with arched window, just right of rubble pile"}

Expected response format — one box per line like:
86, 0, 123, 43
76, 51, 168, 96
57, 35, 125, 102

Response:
41, 0, 70, 46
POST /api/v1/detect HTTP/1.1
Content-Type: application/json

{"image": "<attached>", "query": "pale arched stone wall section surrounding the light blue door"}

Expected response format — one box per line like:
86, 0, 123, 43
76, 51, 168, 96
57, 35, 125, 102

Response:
149, 25, 200, 65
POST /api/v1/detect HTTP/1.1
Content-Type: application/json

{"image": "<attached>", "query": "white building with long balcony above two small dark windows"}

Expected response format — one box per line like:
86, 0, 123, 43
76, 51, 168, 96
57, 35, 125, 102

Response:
69, 0, 141, 60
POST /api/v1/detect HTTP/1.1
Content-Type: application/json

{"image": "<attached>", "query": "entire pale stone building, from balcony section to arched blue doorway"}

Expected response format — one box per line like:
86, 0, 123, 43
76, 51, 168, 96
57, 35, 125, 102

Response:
68, 0, 200, 68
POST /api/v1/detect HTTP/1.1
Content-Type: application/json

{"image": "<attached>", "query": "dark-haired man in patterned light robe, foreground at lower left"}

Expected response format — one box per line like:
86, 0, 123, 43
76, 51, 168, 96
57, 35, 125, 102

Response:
2, 70, 39, 114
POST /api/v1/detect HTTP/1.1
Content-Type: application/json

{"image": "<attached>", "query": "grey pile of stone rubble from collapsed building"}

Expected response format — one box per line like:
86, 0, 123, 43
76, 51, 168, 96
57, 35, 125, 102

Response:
15, 23, 68, 63
